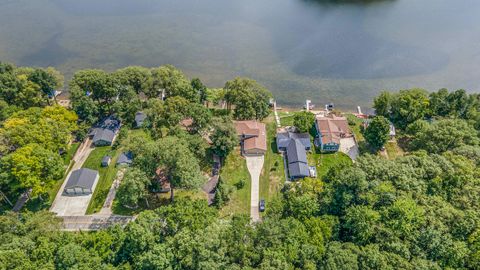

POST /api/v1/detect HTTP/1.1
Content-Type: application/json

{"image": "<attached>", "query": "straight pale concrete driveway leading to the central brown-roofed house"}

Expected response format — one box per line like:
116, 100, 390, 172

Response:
245, 156, 264, 222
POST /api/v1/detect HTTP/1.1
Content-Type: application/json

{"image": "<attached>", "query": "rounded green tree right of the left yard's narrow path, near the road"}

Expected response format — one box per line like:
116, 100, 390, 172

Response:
117, 168, 150, 208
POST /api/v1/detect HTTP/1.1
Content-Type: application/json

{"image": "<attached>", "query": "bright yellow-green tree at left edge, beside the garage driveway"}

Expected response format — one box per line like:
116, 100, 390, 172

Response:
0, 144, 64, 196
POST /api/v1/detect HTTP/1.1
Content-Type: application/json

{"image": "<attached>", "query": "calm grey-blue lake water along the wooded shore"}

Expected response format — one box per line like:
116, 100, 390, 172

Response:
0, 0, 480, 109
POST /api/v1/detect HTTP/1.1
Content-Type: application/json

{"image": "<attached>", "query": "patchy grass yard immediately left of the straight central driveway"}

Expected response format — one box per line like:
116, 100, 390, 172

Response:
220, 148, 252, 217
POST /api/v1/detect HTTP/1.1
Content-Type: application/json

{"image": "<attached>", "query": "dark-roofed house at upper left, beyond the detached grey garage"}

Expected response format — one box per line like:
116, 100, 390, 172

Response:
88, 116, 121, 146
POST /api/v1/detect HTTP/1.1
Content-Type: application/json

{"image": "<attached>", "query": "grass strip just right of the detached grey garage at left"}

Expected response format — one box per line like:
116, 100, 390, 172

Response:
83, 146, 121, 214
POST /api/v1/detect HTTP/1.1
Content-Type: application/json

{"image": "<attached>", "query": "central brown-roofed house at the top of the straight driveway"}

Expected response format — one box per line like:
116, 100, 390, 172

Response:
235, 120, 267, 156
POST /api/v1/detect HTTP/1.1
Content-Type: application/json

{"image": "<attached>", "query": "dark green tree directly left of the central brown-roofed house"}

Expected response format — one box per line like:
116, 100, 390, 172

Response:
210, 117, 239, 157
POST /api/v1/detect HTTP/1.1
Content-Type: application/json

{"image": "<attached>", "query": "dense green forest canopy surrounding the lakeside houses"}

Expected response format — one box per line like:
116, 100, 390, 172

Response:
0, 64, 480, 270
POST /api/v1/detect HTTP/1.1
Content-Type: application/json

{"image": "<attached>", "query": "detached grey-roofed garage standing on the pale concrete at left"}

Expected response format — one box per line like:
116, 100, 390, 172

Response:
64, 168, 99, 195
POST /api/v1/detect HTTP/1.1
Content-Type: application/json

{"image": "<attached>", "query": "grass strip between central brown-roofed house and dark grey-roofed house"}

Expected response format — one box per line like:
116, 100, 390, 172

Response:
260, 116, 285, 202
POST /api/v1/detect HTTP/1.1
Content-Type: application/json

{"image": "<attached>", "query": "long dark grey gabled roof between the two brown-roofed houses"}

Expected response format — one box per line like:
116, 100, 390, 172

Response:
287, 139, 310, 180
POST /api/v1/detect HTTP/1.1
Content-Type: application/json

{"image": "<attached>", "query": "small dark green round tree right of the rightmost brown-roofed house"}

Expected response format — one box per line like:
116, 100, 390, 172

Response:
363, 116, 390, 150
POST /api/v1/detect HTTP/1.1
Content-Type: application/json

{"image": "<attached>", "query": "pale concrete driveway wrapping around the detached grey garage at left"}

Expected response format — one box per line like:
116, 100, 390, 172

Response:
50, 139, 98, 216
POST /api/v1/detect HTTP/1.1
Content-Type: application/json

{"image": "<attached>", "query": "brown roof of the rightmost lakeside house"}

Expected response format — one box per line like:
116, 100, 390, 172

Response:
315, 115, 353, 144
